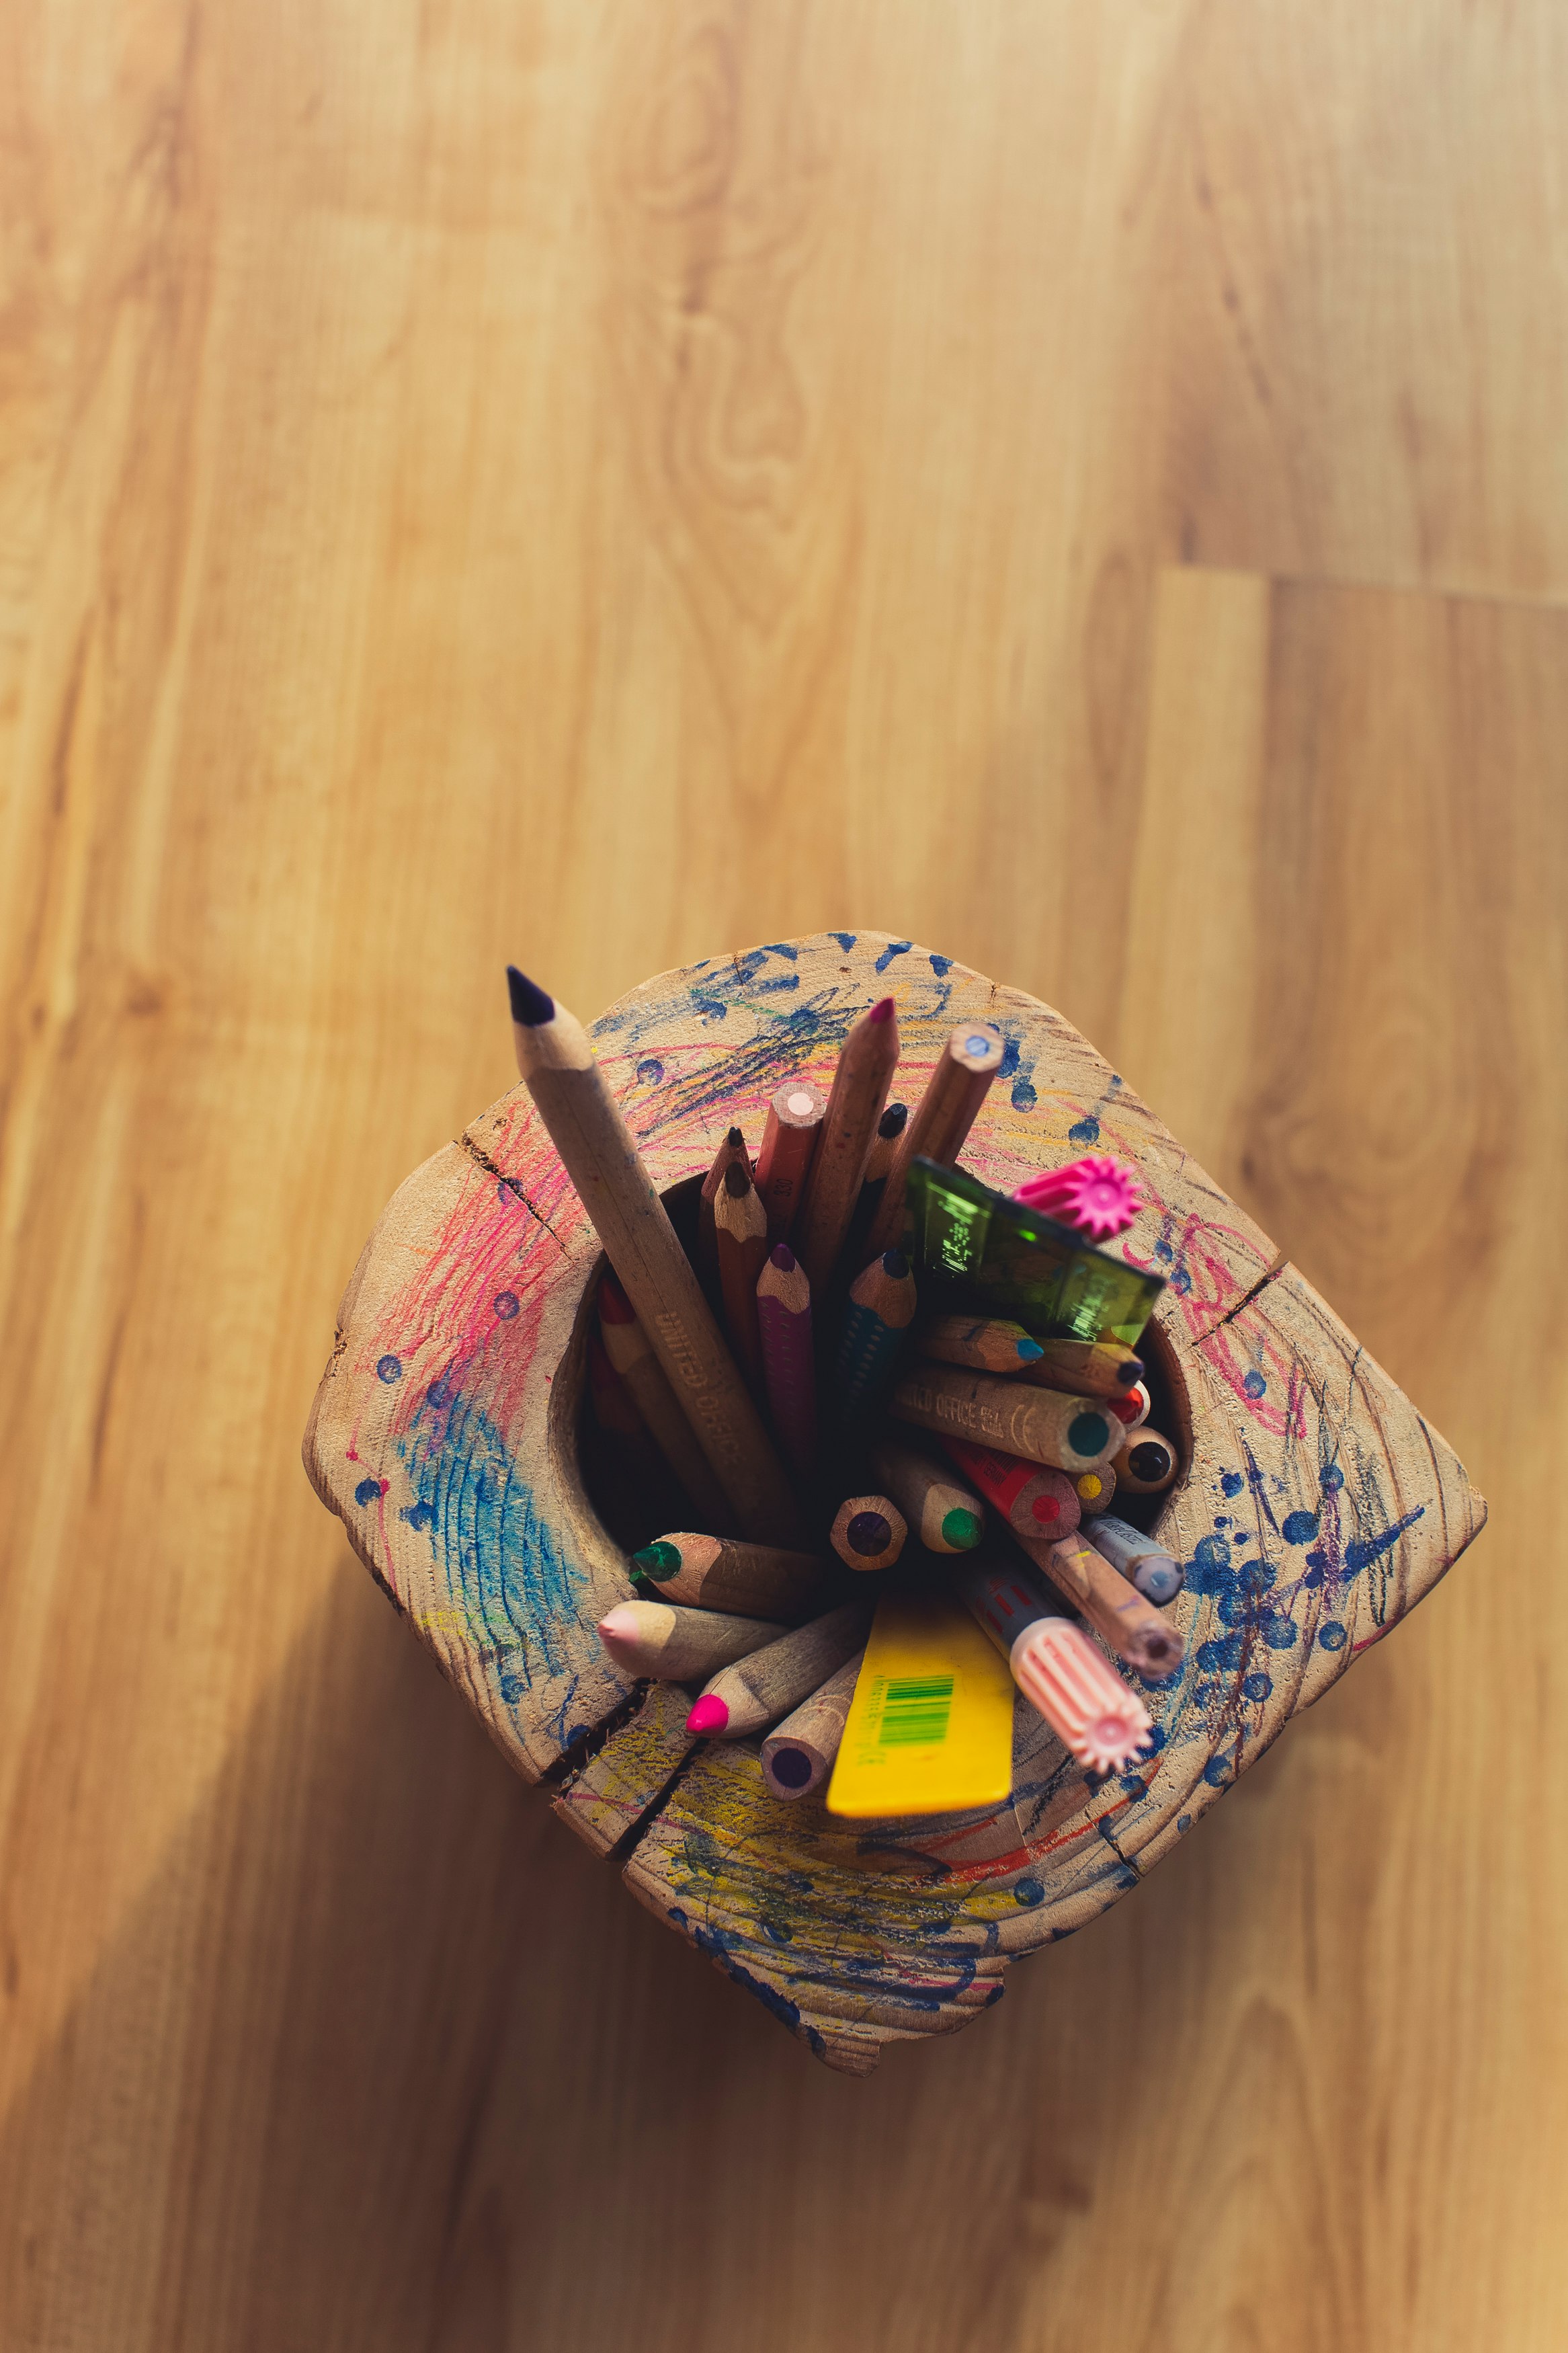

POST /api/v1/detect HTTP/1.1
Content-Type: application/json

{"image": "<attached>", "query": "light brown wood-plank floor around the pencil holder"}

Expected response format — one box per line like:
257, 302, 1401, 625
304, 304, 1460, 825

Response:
0, 0, 1568, 2353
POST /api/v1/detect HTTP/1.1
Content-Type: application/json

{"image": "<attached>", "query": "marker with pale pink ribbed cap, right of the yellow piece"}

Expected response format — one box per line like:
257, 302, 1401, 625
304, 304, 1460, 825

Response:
957, 1562, 1154, 1772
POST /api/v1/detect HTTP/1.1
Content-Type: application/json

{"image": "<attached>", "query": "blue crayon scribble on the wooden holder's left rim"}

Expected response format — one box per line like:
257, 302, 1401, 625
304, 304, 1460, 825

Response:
397, 1396, 583, 1689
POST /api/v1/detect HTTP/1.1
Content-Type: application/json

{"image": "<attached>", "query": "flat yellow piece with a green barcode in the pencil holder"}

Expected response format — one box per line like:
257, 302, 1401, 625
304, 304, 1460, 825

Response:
827, 1593, 1014, 1821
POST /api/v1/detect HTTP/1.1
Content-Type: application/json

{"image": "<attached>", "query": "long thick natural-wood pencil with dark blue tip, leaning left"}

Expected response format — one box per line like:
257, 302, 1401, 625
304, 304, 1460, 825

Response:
508, 969, 802, 1544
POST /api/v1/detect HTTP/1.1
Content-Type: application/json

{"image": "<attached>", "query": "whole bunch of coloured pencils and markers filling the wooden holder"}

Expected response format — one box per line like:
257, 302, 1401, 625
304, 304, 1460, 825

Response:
508, 969, 1182, 1819
